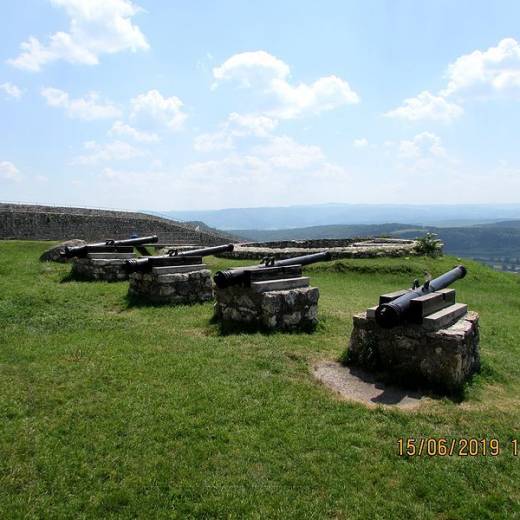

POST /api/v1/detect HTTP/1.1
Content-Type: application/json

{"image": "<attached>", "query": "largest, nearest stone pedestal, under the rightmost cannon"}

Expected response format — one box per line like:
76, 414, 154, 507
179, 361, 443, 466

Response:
345, 310, 480, 393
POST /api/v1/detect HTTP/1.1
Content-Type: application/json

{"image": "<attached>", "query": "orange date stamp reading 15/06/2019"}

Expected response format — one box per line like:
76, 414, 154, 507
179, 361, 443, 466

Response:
397, 437, 520, 457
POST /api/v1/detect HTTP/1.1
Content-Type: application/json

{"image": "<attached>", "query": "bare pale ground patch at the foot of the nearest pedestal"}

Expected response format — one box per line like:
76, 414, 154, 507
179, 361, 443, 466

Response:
313, 361, 429, 410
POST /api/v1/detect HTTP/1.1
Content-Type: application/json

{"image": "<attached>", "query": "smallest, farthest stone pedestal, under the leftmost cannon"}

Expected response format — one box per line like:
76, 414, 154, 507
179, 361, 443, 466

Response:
72, 253, 135, 282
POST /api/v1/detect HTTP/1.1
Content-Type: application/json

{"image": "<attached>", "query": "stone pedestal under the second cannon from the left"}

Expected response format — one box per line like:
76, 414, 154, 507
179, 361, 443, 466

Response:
128, 264, 213, 305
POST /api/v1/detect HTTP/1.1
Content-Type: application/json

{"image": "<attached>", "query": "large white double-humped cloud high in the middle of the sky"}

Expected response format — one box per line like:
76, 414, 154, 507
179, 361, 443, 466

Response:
213, 51, 359, 119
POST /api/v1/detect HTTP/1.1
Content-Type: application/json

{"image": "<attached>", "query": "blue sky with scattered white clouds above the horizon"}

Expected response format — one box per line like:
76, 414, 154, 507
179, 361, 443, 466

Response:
0, 0, 520, 210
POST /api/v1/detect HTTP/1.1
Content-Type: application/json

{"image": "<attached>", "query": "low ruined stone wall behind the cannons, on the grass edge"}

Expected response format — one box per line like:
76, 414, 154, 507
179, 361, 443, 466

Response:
217, 239, 417, 260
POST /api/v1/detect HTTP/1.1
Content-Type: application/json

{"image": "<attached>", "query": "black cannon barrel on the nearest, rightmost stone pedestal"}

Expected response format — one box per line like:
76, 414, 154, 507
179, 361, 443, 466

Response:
376, 265, 467, 329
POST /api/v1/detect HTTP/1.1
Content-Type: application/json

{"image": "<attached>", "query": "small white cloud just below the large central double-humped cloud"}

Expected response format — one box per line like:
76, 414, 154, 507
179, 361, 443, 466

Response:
193, 112, 278, 152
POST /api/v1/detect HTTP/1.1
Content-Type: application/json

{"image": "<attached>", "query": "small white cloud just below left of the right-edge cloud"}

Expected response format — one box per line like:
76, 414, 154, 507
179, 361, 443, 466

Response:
385, 90, 463, 123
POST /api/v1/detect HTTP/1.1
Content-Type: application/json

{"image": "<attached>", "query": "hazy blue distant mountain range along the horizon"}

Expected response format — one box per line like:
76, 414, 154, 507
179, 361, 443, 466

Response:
157, 204, 520, 230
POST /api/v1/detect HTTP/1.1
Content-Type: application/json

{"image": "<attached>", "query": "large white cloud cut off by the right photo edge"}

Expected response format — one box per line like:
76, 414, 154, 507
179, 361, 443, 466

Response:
442, 38, 520, 96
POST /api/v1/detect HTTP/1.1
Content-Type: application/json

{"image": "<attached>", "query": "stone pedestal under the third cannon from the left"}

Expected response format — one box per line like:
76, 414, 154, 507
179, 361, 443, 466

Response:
215, 277, 320, 330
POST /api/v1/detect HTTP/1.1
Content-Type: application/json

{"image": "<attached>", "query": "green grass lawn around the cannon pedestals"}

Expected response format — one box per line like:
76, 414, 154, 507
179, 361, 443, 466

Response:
0, 242, 520, 519
